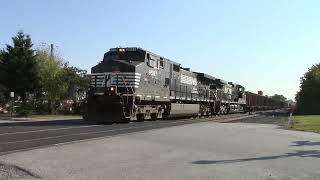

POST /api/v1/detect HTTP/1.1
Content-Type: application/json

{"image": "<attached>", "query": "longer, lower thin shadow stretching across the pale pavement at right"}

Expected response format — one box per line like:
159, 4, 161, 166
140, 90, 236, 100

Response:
192, 150, 320, 164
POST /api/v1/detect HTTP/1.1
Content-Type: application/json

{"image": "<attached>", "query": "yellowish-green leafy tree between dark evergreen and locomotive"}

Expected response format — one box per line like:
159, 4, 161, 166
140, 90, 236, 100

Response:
37, 48, 89, 113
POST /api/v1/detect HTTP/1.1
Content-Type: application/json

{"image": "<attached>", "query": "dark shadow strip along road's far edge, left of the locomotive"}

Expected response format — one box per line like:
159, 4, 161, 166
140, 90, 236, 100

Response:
0, 119, 95, 127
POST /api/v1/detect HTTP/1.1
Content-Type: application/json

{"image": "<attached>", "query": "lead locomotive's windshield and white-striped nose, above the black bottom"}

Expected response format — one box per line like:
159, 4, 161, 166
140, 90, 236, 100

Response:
91, 48, 146, 95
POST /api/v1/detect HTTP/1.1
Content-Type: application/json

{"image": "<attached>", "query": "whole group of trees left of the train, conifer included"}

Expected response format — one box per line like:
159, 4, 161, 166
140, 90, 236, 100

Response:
0, 31, 89, 116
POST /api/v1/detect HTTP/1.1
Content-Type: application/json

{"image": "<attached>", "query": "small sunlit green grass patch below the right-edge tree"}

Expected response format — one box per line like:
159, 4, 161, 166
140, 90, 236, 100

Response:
292, 115, 320, 133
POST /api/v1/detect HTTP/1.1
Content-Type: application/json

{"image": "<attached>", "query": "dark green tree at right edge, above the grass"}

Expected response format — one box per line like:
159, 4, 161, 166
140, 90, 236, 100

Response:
296, 63, 320, 114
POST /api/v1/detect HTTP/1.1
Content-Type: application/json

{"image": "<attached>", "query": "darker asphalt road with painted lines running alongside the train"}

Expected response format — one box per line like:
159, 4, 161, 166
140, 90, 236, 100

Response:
0, 114, 252, 155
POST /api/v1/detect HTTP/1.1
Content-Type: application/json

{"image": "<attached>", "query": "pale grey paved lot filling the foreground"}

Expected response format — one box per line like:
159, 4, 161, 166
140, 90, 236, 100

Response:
0, 115, 320, 180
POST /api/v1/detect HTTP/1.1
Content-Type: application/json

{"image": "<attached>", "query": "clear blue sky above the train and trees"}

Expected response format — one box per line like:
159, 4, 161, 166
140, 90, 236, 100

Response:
0, 0, 320, 98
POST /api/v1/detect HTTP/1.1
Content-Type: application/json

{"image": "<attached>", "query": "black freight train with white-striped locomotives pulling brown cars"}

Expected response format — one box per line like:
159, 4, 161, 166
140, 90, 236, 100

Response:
84, 47, 283, 123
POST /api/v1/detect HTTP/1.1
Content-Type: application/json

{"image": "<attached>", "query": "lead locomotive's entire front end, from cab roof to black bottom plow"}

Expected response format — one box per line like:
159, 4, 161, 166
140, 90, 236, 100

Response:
85, 48, 146, 122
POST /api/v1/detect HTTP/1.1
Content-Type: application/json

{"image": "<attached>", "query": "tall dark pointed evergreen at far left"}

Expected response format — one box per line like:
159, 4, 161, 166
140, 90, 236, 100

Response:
0, 31, 39, 105
